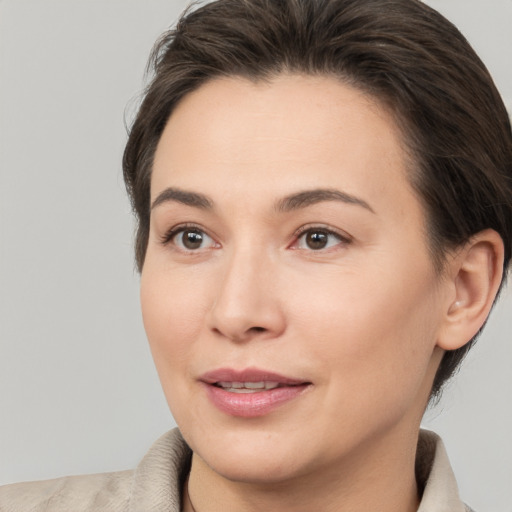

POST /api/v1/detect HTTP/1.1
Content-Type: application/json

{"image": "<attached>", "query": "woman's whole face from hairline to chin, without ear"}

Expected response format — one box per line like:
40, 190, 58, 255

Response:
141, 76, 447, 482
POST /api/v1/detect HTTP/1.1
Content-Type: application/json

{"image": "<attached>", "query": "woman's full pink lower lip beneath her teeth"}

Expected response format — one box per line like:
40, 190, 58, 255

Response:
204, 383, 310, 418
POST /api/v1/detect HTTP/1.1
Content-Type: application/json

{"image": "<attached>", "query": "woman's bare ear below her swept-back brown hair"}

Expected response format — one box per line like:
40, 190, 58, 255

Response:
437, 229, 504, 350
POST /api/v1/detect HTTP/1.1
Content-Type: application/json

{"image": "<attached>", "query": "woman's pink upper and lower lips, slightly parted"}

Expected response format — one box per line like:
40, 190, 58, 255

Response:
199, 368, 311, 418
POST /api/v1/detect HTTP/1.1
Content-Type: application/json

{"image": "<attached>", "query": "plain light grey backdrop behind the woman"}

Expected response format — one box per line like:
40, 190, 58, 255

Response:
0, 0, 512, 512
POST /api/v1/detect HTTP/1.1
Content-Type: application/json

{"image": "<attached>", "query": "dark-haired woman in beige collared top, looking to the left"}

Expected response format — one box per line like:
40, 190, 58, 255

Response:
0, 0, 512, 512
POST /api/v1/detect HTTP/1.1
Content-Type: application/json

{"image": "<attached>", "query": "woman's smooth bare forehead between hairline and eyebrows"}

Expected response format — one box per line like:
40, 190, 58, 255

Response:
151, 75, 415, 222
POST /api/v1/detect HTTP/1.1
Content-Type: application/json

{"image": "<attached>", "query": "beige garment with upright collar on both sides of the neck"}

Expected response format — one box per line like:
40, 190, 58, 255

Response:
0, 429, 472, 512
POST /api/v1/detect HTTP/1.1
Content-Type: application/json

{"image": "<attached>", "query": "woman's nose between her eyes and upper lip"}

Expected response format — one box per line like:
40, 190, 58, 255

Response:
209, 245, 286, 343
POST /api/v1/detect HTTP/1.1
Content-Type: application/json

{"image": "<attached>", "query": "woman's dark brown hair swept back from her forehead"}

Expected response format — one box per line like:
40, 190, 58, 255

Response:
123, 0, 512, 397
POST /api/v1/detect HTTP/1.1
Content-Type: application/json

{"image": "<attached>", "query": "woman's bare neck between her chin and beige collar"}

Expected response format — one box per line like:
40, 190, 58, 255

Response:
183, 428, 419, 512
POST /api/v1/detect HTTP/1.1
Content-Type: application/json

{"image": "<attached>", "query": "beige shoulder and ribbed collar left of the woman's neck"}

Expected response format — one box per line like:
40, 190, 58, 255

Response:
0, 429, 191, 512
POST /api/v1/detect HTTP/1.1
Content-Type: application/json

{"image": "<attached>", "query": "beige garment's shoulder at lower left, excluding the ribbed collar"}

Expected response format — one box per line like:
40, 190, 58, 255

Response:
0, 471, 133, 512
